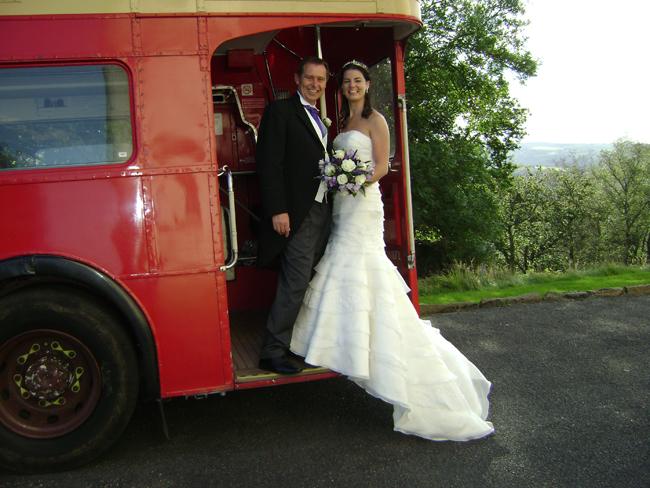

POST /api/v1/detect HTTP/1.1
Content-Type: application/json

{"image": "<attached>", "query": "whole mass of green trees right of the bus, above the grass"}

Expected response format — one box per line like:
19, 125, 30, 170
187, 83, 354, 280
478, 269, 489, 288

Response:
405, 0, 650, 273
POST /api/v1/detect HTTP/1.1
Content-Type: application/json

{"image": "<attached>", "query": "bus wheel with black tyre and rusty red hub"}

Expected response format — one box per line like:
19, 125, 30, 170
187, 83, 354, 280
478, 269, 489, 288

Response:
0, 285, 138, 473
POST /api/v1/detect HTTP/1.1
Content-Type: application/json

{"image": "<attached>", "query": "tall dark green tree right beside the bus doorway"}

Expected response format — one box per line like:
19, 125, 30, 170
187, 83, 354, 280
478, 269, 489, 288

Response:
405, 0, 537, 268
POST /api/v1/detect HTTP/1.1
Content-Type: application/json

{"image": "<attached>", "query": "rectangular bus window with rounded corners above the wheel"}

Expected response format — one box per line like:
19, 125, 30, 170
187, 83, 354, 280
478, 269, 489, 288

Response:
0, 65, 133, 170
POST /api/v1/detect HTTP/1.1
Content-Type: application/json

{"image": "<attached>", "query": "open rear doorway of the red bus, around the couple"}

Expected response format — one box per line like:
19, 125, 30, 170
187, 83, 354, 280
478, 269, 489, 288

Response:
211, 24, 412, 388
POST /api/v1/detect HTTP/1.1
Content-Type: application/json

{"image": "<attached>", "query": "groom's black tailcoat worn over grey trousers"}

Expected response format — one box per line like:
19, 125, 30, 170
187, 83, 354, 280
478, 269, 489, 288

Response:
257, 93, 331, 267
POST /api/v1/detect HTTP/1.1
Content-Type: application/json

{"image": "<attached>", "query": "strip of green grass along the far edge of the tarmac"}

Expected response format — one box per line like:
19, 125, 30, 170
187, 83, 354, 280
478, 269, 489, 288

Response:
418, 264, 650, 304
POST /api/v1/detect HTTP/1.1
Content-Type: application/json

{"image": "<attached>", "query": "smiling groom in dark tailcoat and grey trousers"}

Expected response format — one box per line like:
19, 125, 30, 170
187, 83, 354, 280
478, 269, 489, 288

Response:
257, 57, 332, 374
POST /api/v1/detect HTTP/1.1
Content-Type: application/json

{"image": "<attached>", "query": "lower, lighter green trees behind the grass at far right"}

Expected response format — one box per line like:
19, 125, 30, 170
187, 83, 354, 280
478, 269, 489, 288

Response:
488, 139, 650, 273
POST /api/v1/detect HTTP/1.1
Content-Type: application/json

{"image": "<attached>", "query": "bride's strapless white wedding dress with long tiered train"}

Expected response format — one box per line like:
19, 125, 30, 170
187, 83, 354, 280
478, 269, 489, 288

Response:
291, 131, 494, 441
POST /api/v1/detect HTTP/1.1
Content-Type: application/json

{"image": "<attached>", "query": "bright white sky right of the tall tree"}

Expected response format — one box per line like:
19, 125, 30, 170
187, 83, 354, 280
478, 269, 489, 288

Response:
510, 0, 650, 144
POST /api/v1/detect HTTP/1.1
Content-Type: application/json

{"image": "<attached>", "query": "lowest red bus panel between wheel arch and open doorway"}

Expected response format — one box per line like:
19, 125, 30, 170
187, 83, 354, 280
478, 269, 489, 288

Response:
127, 273, 232, 398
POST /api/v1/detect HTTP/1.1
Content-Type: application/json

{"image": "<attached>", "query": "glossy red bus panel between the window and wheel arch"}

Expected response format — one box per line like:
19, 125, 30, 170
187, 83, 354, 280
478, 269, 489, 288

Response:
0, 178, 148, 276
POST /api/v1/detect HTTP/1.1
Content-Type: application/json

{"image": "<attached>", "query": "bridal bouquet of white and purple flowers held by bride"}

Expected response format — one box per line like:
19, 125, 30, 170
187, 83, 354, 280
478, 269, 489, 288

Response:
317, 149, 374, 196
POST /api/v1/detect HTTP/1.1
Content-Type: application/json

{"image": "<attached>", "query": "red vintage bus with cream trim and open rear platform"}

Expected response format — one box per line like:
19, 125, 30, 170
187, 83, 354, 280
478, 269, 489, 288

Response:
0, 0, 420, 471
